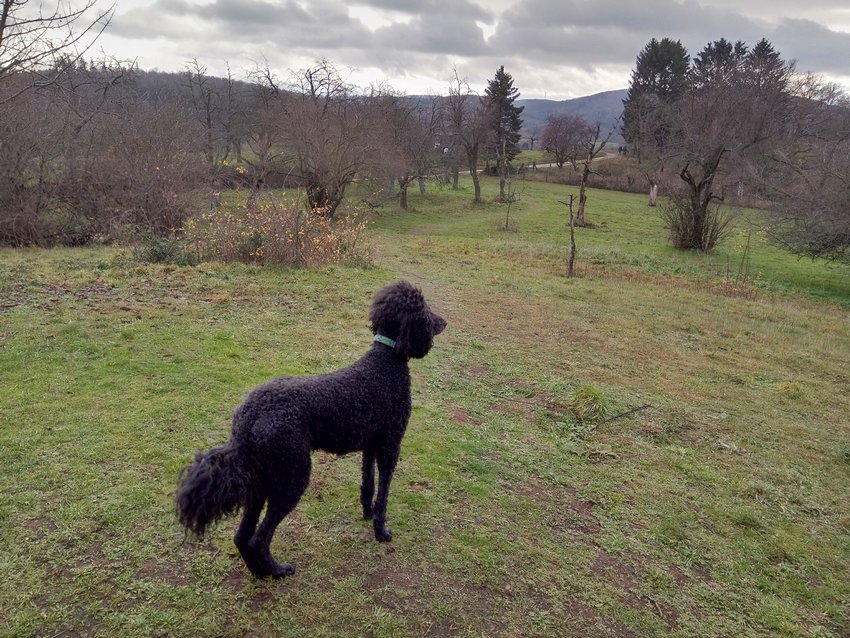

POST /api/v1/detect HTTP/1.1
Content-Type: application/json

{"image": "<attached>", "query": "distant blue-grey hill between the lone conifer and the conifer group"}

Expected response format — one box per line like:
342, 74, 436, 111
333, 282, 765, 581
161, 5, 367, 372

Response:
516, 89, 627, 142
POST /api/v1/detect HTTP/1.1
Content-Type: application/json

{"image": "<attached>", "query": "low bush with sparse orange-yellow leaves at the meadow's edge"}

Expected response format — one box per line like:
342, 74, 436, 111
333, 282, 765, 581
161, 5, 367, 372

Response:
182, 197, 370, 266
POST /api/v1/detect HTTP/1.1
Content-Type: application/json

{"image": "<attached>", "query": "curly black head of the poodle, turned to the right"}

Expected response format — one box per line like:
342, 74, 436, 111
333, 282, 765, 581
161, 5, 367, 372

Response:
369, 281, 446, 359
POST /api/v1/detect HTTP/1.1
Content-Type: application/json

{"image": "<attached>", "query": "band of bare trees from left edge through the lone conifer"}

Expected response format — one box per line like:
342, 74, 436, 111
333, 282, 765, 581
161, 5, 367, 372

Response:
0, 0, 522, 246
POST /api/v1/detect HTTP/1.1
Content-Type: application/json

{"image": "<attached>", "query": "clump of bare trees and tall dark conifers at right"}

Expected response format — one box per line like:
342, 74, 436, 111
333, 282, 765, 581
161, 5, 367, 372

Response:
622, 38, 850, 260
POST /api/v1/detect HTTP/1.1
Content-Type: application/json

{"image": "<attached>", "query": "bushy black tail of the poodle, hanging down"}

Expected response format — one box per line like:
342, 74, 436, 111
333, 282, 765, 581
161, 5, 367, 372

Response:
177, 441, 253, 537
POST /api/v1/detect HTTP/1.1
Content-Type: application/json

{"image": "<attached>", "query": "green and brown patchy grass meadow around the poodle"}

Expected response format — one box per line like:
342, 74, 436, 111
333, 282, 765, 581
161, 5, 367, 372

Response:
0, 180, 850, 637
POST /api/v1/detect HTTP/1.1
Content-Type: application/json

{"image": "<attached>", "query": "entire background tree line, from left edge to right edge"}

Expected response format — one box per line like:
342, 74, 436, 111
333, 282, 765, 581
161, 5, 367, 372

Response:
0, 0, 850, 260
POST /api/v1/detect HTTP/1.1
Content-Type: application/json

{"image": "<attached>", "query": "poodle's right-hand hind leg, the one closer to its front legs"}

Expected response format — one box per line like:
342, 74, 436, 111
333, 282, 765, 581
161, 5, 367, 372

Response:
245, 449, 310, 578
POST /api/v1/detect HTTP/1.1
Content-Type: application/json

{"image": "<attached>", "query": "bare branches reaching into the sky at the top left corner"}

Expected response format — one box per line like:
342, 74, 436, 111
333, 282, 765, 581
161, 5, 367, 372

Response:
0, 0, 114, 104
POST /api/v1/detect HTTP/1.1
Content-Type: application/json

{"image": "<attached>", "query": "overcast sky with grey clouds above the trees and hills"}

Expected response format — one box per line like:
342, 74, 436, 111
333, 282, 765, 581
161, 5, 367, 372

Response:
81, 0, 850, 100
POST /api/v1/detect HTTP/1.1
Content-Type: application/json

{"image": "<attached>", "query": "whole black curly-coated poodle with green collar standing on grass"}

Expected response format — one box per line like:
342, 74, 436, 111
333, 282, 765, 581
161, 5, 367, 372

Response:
177, 281, 446, 578
